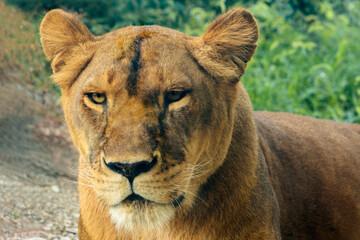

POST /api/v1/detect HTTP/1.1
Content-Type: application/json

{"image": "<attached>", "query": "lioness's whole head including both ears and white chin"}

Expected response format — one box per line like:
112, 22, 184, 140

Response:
40, 8, 258, 230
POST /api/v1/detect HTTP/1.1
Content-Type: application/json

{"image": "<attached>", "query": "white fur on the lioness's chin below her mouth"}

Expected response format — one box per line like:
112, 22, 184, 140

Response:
109, 205, 175, 232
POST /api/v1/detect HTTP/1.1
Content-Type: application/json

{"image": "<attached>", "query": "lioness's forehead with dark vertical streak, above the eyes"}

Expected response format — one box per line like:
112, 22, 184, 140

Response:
83, 26, 196, 96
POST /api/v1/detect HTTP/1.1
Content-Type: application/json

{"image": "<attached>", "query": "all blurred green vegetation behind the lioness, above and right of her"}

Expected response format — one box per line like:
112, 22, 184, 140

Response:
0, 0, 360, 123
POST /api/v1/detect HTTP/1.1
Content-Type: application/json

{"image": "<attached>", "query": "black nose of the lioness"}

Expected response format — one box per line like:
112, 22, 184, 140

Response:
103, 157, 157, 183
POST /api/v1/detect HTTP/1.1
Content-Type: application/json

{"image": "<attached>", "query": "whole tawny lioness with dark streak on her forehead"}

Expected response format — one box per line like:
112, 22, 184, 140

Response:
40, 8, 360, 240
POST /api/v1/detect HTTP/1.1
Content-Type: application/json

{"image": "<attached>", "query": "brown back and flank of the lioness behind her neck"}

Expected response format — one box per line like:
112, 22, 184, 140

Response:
255, 112, 360, 239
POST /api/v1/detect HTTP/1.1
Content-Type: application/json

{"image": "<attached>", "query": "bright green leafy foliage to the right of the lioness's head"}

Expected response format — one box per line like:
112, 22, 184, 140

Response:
243, 0, 360, 122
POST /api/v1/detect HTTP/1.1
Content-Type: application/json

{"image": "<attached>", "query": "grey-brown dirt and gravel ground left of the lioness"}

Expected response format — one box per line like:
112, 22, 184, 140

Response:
0, 75, 79, 240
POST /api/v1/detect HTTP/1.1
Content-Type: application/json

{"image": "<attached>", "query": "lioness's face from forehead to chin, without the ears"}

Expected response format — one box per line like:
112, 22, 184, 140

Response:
69, 28, 236, 229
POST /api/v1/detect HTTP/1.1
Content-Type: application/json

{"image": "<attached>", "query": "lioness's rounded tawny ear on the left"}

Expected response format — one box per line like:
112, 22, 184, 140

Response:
40, 9, 94, 73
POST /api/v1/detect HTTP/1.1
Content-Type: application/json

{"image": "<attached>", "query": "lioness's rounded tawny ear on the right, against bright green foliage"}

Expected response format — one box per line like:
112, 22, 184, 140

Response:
192, 8, 259, 82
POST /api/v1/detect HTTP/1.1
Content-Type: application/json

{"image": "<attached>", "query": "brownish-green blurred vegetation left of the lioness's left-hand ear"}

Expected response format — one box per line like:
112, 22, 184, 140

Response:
0, 0, 51, 88
